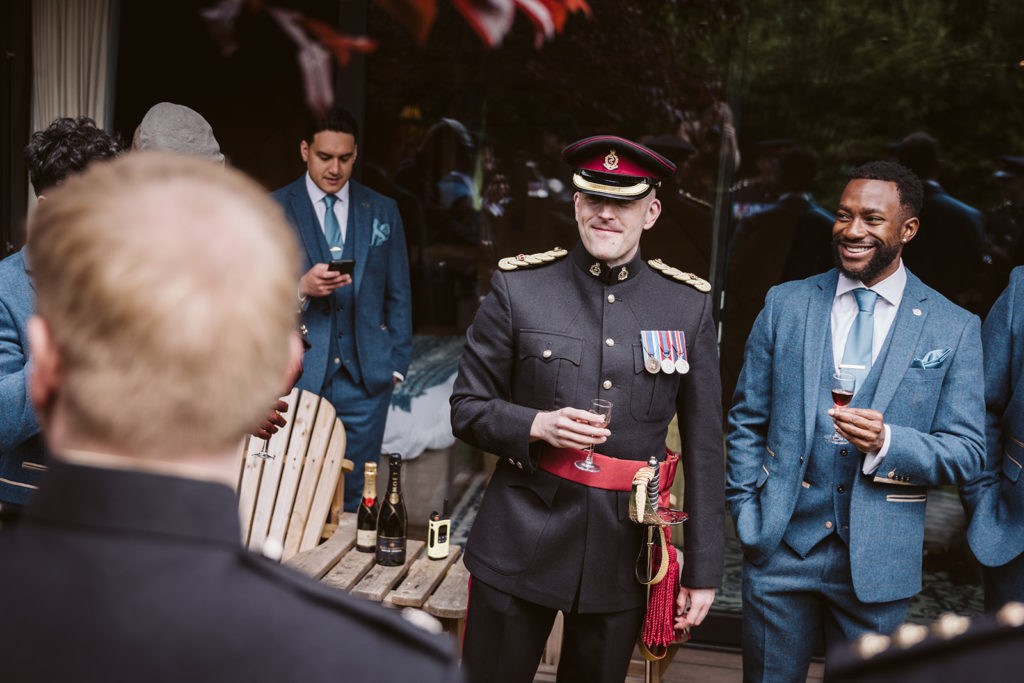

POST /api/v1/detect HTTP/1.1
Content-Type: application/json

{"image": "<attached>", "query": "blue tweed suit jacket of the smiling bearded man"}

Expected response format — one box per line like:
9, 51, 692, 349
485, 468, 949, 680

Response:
726, 269, 984, 602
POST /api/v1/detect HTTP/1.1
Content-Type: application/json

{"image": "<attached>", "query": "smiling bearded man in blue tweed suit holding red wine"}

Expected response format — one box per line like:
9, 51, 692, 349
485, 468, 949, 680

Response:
726, 162, 984, 682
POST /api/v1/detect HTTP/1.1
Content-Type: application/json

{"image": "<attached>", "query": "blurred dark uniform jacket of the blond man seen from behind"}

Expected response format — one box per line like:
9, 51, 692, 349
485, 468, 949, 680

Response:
0, 462, 460, 683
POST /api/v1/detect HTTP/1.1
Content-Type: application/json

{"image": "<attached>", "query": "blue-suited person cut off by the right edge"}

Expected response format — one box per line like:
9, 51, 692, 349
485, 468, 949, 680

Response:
961, 267, 1024, 609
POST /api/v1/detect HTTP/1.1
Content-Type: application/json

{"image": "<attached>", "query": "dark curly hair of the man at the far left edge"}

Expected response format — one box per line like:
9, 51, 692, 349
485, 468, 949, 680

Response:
25, 116, 125, 195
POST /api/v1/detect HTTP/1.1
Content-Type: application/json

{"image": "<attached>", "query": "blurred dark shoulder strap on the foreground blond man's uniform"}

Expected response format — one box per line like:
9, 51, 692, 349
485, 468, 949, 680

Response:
243, 552, 458, 680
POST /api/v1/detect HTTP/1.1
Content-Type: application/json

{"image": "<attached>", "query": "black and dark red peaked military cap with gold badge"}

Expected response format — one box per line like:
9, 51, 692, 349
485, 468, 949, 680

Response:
562, 135, 676, 200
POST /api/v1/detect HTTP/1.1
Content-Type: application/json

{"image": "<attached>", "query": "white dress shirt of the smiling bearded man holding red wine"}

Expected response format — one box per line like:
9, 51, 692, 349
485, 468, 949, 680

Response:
831, 259, 906, 474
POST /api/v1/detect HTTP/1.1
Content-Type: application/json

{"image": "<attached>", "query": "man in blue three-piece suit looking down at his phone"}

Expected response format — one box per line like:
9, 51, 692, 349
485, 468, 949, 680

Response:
273, 109, 413, 512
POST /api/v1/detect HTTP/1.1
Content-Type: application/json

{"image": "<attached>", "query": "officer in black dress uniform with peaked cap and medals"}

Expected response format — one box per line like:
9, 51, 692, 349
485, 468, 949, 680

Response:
452, 136, 724, 682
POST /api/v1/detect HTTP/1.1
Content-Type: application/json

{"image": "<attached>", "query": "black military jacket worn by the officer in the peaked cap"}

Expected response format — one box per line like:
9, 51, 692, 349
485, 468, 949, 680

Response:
452, 246, 725, 612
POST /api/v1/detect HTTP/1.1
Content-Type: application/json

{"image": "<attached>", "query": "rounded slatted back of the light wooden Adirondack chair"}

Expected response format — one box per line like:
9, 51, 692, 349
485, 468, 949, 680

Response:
238, 389, 352, 561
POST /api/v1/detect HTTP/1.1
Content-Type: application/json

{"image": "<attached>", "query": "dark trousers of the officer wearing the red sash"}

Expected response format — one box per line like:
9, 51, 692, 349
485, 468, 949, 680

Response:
462, 578, 644, 683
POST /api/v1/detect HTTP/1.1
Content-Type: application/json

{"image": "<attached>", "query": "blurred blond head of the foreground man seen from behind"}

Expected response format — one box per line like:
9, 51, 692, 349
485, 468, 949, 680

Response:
29, 152, 299, 456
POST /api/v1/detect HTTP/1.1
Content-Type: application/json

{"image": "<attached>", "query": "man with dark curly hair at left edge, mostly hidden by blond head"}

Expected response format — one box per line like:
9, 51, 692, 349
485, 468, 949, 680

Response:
0, 117, 122, 510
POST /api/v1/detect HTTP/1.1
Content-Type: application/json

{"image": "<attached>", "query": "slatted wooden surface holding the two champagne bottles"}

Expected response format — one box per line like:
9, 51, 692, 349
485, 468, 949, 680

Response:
286, 512, 469, 645
